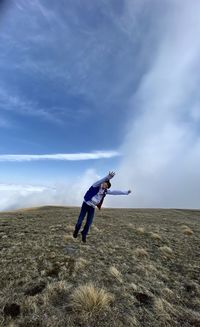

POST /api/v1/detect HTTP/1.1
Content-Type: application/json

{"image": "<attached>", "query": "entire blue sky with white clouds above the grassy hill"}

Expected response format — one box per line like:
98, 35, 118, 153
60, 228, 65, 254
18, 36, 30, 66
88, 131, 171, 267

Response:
0, 0, 200, 210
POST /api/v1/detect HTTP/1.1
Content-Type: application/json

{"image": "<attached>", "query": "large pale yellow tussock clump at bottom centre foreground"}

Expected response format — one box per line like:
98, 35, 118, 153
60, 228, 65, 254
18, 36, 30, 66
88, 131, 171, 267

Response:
70, 283, 114, 313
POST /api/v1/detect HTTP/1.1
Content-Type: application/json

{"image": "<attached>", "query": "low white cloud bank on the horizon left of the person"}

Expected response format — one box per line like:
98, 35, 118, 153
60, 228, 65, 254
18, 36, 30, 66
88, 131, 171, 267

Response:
0, 169, 100, 210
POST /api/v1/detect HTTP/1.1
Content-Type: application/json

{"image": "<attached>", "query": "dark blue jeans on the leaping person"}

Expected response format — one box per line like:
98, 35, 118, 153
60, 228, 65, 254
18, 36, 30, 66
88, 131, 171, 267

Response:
75, 202, 95, 236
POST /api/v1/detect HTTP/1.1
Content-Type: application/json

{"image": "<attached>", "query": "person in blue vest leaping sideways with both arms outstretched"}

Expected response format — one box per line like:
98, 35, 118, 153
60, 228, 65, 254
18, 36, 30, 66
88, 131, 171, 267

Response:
73, 171, 131, 243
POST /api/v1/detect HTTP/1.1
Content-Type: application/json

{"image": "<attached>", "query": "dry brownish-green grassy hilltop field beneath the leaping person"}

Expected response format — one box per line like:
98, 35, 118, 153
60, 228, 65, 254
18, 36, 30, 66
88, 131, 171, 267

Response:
0, 206, 200, 327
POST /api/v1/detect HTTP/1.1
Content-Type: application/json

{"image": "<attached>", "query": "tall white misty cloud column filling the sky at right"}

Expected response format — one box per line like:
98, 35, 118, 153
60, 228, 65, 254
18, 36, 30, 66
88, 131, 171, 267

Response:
110, 1, 200, 208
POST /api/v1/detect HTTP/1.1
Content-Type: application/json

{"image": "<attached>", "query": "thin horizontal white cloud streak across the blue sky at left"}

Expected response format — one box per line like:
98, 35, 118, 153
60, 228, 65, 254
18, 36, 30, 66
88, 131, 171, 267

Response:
0, 151, 120, 162
